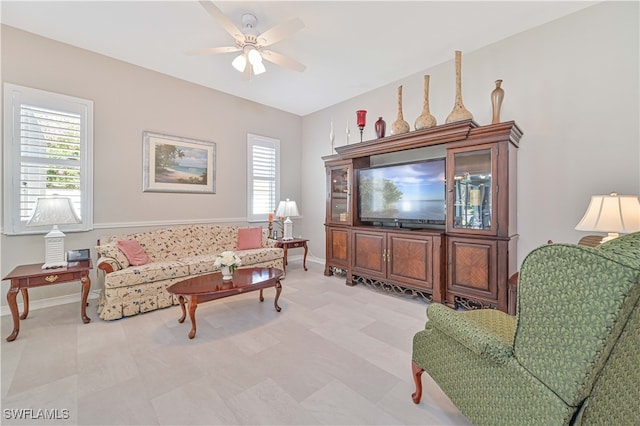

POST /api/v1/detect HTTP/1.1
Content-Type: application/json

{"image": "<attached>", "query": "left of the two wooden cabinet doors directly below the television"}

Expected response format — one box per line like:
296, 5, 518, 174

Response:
352, 231, 387, 278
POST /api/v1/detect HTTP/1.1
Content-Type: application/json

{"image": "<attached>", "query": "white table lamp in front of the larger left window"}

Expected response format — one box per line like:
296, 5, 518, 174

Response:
27, 197, 80, 269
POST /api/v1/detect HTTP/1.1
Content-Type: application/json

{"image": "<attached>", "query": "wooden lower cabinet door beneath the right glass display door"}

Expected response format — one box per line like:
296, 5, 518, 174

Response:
447, 237, 499, 305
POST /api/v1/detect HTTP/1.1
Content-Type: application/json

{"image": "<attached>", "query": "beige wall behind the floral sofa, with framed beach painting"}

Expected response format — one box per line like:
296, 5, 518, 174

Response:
0, 26, 304, 305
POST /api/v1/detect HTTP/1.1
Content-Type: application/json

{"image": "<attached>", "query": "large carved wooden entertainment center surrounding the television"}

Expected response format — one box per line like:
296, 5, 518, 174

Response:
323, 120, 522, 312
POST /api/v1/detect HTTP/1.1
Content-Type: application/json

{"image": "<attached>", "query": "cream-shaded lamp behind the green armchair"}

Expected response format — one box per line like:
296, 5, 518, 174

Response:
576, 192, 640, 243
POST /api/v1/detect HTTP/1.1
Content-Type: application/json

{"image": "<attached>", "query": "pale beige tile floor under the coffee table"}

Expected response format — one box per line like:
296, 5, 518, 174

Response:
0, 262, 469, 425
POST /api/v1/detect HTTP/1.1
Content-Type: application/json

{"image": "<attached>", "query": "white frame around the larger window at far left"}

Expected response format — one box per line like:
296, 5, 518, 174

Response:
3, 83, 93, 235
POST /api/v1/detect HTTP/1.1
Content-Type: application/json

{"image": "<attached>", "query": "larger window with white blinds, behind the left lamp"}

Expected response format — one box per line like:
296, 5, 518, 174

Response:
4, 83, 93, 234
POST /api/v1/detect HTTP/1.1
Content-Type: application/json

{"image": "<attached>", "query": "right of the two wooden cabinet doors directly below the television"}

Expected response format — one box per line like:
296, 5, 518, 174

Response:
387, 234, 433, 289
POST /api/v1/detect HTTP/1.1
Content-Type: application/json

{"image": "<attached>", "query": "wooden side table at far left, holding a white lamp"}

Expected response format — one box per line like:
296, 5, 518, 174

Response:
2, 260, 93, 342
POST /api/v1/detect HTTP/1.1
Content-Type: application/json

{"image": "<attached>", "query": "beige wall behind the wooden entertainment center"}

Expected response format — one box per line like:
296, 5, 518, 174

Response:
302, 2, 640, 264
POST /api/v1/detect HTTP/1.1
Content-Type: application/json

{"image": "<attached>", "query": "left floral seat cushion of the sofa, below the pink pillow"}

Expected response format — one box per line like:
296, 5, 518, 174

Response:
104, 261, 189, 288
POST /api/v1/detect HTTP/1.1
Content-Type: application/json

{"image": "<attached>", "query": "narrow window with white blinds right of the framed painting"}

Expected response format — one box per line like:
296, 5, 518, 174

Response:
247, 134, 280, 221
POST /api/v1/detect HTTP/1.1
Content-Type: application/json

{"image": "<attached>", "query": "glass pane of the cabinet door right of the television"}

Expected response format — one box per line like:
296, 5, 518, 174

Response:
452, 148, 494, 230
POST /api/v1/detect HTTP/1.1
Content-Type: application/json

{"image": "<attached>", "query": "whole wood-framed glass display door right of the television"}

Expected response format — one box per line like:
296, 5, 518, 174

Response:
447, 144, 498, 235
